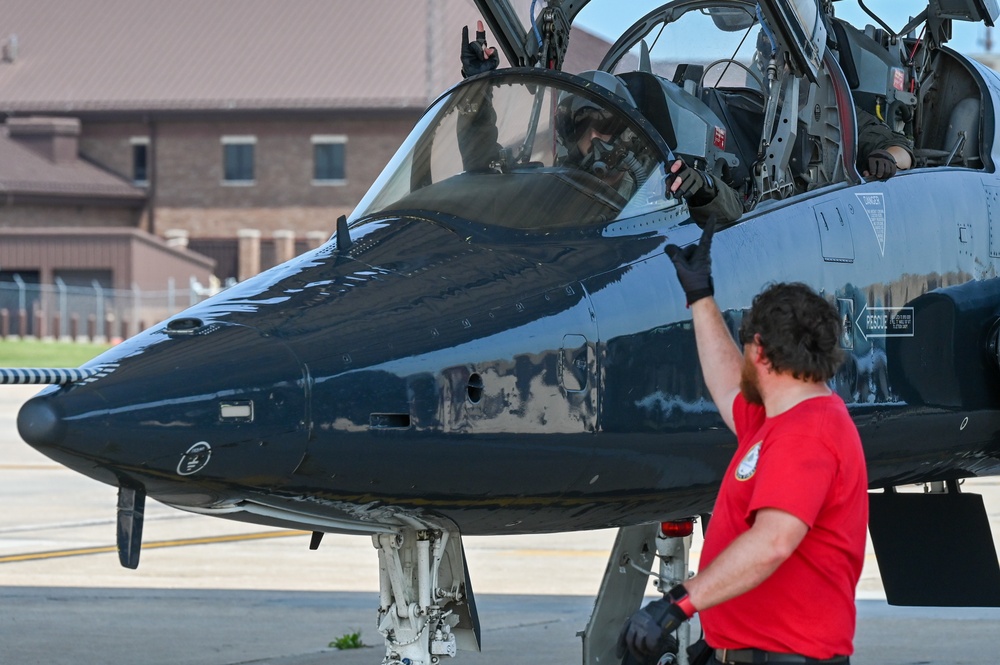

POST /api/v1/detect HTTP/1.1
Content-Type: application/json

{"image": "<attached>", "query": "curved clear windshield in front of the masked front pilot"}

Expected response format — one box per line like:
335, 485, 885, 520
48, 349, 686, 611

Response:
352, 69, 678, 229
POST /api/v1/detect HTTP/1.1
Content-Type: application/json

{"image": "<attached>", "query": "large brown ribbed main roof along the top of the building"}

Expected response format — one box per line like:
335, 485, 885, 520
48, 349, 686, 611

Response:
0, 0, 608, 114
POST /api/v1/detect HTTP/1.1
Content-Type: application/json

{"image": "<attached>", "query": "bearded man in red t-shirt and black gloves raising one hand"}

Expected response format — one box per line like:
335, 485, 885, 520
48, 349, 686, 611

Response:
619, 222, 868, 664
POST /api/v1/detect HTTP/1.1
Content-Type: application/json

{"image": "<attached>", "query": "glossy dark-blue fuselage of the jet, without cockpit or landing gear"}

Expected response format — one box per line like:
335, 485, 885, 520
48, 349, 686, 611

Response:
22, 59, 1000, 534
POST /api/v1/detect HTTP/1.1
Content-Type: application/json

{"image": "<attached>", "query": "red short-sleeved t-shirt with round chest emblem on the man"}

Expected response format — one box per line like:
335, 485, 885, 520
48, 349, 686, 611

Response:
701, 395, 868, 658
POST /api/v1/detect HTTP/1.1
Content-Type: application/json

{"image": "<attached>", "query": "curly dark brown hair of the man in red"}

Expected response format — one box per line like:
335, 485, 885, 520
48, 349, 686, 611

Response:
739, 282, 844, 381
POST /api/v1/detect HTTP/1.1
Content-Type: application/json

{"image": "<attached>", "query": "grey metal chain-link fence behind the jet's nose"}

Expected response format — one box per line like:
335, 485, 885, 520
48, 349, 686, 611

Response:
0, 275, 219, 342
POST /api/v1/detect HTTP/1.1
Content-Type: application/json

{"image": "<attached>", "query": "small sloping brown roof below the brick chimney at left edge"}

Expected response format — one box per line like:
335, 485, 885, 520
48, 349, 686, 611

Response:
0, 121, 146, 200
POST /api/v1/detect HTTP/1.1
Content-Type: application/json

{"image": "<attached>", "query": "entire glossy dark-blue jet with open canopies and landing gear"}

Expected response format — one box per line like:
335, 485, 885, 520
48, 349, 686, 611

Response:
3, 0, 1000, 665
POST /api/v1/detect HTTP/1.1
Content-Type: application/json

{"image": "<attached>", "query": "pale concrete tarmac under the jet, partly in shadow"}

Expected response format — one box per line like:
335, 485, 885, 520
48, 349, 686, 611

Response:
0, 386, 1000, 665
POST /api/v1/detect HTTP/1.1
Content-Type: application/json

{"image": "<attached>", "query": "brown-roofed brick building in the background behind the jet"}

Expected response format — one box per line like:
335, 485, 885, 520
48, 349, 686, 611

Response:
0, 0, 608, 281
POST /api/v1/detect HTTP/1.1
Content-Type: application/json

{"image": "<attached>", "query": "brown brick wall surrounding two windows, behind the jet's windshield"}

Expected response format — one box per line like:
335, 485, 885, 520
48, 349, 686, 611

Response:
81, 112, 419, 238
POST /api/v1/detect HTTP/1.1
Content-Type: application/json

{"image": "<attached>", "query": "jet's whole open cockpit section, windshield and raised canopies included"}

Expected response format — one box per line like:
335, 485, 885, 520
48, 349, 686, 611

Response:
352, 0, 998, 232
